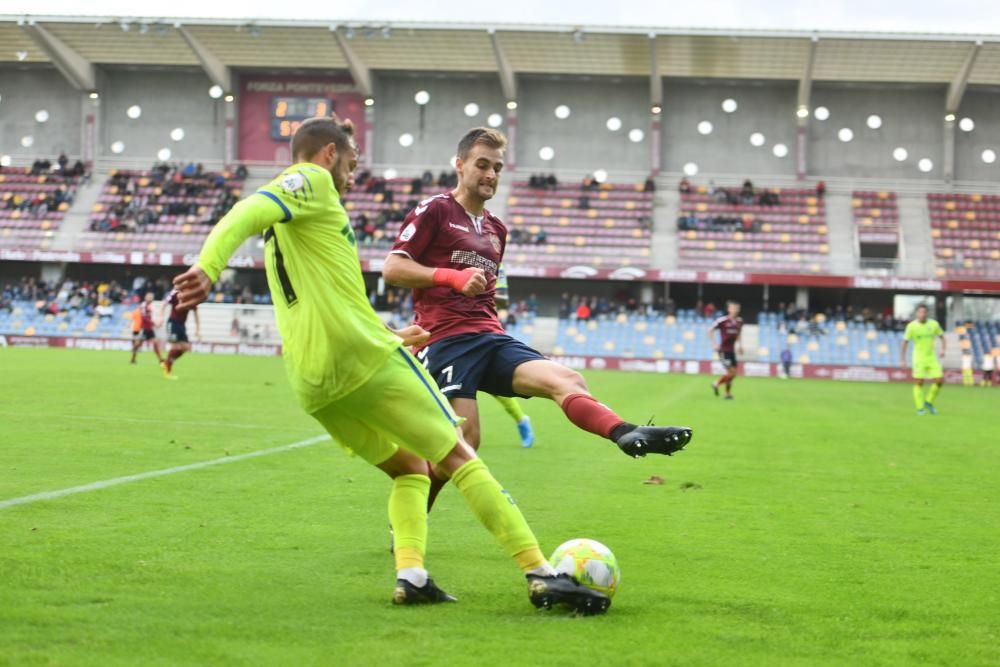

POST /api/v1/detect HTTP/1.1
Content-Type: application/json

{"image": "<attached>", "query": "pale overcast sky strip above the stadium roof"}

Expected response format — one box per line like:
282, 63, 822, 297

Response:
0, 0, 1000, 35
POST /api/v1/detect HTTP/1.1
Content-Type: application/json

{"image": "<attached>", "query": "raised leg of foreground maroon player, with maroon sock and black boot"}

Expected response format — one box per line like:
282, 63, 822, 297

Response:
512, 359, 692, 457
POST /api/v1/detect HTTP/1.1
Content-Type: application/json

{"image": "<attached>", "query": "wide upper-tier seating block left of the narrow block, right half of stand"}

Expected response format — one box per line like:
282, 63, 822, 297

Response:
677, 186, 830, 273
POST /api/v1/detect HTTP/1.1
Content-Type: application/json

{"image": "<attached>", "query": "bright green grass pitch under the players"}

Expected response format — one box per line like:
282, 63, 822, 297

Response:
0, 349, 1000, 667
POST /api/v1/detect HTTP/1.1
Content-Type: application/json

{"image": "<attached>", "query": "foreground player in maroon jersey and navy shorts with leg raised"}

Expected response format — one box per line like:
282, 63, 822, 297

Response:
382, 127, 691, 502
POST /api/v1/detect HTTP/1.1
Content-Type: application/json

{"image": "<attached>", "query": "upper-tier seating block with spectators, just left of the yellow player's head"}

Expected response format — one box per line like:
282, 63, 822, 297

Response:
77, 165, 243, 254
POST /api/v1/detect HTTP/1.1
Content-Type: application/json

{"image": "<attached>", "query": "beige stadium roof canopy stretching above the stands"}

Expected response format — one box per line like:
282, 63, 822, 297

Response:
0, 16, 1000, 87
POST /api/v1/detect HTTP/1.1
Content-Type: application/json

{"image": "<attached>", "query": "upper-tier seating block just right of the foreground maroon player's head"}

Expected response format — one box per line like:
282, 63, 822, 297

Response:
506, 181, 653, 267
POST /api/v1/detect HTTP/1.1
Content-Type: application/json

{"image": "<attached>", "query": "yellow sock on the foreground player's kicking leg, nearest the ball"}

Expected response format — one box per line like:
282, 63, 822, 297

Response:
454, 459, 545, 572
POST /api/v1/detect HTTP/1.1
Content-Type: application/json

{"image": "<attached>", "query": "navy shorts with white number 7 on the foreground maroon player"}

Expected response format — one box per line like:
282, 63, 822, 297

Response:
417, 333, 545, 398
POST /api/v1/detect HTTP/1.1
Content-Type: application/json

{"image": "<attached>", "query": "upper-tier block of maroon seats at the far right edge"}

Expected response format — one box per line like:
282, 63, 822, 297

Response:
927, 193, 1000, 278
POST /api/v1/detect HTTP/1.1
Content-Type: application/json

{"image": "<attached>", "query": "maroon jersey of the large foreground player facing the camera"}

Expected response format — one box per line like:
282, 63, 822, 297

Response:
392, 193, 507, 345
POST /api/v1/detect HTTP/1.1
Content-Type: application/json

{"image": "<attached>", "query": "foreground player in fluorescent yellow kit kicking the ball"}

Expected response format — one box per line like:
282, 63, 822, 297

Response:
174, 117, 610, 614
